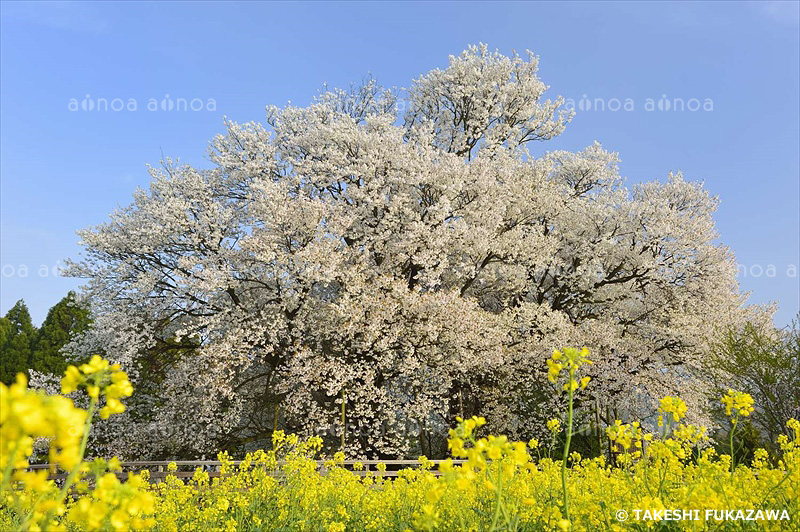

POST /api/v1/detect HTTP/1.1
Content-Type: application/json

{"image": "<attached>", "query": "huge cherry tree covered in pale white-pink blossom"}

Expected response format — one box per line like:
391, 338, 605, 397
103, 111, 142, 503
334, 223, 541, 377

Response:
61, 46, 755, 457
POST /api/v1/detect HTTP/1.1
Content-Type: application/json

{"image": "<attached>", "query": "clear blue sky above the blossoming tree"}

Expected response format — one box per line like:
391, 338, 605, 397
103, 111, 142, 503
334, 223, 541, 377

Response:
0, 2, 800, 325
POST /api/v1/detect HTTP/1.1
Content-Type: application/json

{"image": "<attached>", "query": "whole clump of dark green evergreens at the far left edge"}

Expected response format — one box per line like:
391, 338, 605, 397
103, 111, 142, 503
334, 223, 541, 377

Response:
0, 292, 91, 384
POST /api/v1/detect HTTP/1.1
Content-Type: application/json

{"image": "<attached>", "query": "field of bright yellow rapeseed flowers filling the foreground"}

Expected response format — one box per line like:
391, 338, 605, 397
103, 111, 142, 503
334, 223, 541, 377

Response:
0, 348, 800, 532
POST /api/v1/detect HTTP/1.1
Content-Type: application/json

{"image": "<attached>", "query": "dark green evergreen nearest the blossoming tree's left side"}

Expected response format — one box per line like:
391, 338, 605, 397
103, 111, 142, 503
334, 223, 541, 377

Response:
29, 291, 91, 375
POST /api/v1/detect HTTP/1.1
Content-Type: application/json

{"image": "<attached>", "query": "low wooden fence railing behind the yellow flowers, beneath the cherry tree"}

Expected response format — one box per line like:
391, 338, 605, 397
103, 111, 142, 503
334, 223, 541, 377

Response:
27, 460, 465, 482
